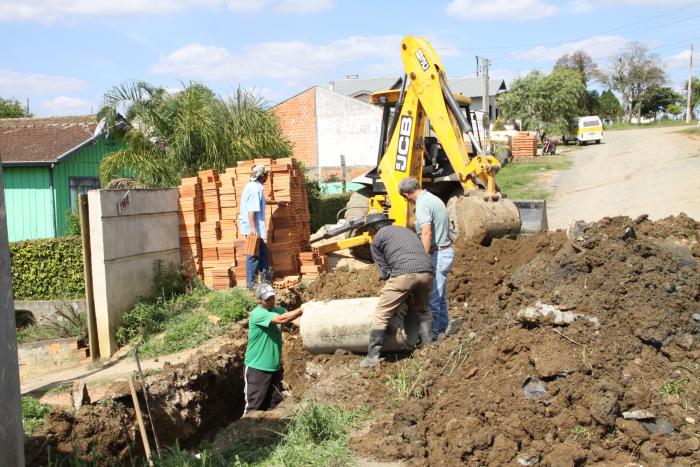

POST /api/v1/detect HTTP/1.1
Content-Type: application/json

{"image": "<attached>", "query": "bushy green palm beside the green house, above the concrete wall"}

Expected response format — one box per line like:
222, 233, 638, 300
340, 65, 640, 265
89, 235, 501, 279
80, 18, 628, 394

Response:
100, 81, 292, 187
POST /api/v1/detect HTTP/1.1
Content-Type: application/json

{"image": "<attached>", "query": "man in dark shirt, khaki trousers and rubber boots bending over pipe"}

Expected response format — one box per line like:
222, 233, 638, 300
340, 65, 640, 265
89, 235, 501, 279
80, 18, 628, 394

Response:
360, 214, 433, 367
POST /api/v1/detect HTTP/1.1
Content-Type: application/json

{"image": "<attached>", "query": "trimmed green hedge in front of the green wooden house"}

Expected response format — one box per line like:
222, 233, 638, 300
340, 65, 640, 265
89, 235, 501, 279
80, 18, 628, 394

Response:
10, 237, 85, 300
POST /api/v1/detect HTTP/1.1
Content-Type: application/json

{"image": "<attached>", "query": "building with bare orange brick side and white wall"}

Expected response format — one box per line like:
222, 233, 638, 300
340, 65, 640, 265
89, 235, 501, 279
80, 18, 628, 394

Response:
272, 87, 382, 182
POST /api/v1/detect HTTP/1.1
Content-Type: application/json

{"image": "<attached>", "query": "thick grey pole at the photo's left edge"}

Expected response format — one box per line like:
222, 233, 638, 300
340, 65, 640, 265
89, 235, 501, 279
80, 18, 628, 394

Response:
0, 165, 24, 466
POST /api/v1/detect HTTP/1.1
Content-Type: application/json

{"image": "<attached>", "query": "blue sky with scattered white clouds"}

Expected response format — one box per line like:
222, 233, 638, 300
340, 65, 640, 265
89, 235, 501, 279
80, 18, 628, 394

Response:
0, 0, 700, 116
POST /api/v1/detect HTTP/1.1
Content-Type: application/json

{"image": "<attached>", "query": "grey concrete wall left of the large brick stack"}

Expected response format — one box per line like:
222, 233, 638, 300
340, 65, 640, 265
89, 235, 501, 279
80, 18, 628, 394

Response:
88, 189, 180, 357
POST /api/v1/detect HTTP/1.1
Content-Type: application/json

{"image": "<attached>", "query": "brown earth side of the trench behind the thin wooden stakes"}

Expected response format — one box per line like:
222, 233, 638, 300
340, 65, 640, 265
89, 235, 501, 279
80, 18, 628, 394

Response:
25, 326, 246, 465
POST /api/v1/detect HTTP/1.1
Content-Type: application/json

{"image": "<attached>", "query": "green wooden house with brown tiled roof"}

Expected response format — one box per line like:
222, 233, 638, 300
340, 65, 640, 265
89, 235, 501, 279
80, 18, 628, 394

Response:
0, 116, 121, 241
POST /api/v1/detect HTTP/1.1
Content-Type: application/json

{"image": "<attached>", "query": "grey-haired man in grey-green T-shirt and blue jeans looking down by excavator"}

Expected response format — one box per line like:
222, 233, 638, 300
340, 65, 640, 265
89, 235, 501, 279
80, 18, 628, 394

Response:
399, 177, 455, 339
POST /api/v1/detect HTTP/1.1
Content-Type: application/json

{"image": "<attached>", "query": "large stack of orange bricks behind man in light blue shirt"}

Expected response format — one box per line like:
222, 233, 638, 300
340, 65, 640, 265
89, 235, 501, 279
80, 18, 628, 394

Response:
179, 158, 328, 289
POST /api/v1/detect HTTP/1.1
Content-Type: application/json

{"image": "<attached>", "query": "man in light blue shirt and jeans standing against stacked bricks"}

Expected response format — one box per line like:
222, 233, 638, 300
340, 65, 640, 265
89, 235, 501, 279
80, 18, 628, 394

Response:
238, 165, 285, 287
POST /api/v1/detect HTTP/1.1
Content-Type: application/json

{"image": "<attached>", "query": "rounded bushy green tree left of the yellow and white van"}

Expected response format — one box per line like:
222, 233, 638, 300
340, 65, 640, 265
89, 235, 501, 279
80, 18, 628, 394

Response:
498, 69, 585, 140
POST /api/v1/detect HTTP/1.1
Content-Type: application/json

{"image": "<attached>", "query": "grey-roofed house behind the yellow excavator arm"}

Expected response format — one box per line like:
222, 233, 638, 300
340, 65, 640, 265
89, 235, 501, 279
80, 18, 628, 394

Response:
328, 77, 506, 120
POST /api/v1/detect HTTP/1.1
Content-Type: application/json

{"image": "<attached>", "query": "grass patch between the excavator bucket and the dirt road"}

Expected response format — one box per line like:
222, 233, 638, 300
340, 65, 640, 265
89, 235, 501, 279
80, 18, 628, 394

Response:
496, 156, 573, 199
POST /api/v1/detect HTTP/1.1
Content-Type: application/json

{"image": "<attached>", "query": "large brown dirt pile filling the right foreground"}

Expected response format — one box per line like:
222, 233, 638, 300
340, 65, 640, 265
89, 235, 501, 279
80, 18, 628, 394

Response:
297, 215, 700, 466
